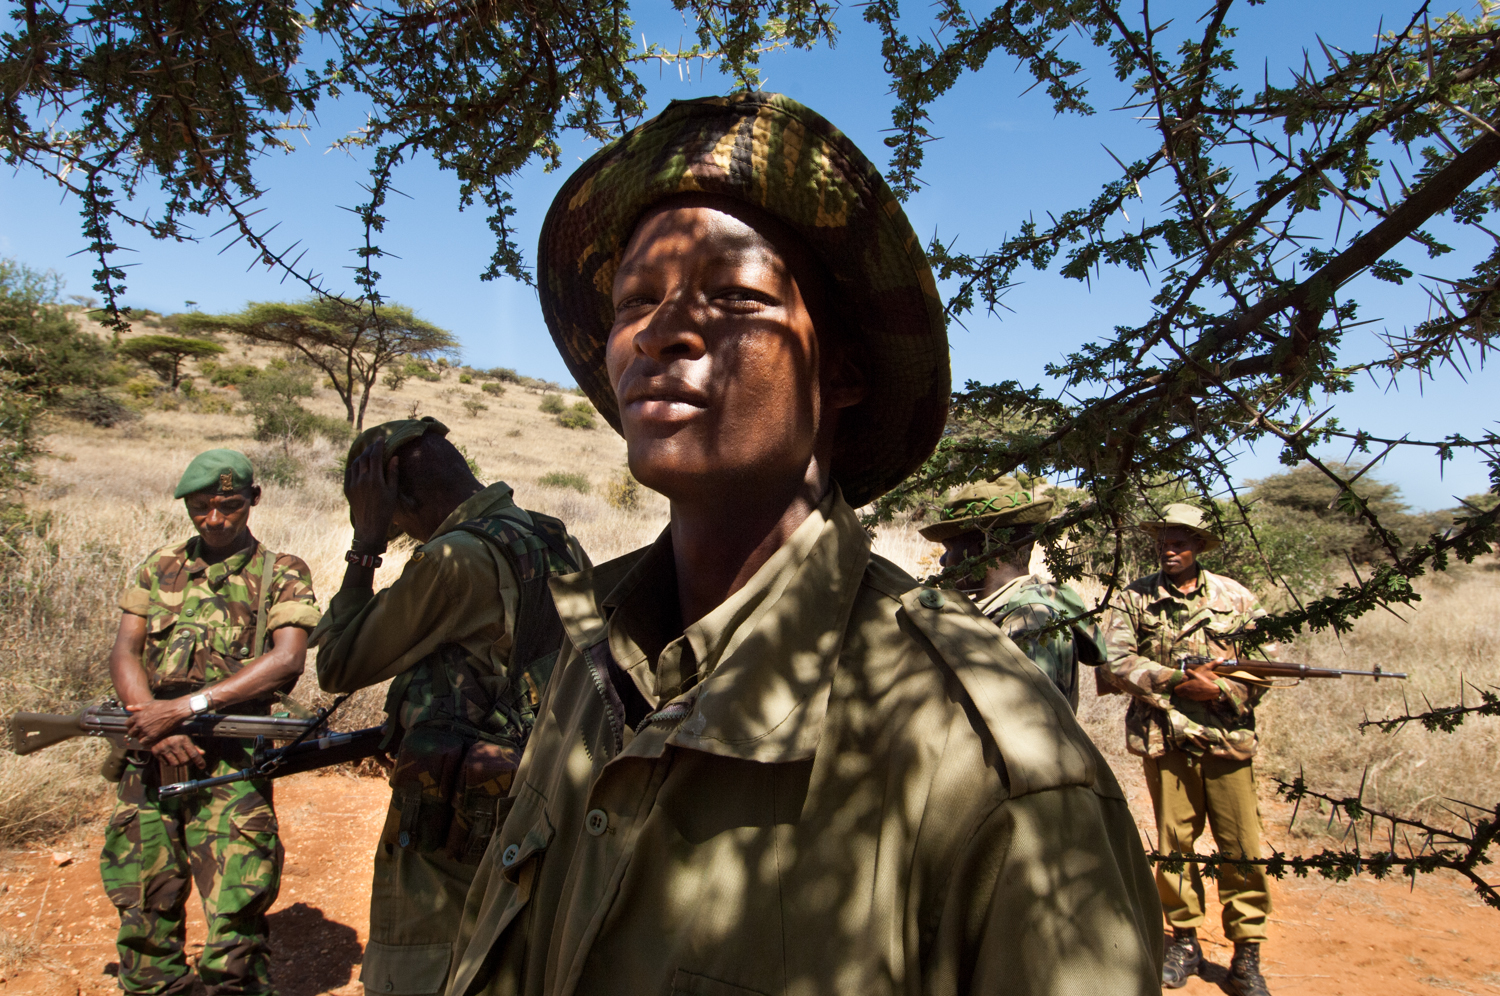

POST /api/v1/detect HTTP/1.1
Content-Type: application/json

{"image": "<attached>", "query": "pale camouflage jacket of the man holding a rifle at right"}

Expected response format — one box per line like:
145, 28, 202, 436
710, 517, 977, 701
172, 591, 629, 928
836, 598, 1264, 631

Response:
1100, 570, 1266, 761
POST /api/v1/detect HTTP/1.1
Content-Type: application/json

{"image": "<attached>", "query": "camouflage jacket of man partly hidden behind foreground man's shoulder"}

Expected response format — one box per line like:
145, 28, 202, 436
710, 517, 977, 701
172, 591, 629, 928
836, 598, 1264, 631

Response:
978, 575, 1104, 713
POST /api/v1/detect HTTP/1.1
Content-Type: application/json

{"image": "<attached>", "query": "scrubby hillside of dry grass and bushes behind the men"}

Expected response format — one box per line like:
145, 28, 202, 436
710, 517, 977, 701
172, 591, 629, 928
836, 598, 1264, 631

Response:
0, 270, 1500, 870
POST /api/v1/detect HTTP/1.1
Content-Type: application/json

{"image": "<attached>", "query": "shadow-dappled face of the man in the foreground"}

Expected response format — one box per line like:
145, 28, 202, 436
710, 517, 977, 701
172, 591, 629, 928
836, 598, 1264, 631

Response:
606, 200, 863, 503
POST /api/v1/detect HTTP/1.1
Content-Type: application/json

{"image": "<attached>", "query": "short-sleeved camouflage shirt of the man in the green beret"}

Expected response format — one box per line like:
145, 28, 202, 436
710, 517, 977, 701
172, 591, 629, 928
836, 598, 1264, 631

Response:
120, 537, 320, 695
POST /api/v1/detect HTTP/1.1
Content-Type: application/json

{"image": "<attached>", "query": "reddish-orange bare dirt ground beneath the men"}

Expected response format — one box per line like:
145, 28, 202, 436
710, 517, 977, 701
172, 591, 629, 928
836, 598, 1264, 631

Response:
0, 776, 1500, 996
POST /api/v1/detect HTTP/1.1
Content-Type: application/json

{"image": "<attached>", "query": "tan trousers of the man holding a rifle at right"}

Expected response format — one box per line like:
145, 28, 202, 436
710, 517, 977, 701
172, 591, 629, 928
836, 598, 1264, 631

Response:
1145, 750, 1271, 942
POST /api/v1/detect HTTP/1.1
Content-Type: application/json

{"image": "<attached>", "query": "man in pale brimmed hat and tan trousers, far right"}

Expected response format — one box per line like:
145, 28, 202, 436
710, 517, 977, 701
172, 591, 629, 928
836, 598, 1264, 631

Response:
1100, 504, 1271, 996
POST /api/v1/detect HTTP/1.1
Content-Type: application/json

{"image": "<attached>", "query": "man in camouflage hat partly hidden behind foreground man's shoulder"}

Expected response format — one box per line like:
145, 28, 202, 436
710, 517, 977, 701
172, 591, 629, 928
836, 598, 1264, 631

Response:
920, 477, 1104, 713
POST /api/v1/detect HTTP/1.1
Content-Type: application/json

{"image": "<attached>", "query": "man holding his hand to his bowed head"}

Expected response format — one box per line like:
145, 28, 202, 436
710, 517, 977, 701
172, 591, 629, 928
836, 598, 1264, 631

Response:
314, 417, 588, 996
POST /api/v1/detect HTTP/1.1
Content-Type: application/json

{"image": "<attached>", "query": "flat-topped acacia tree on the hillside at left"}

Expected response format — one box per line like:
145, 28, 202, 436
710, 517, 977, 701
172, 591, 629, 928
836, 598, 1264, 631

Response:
173, 297, 459, 432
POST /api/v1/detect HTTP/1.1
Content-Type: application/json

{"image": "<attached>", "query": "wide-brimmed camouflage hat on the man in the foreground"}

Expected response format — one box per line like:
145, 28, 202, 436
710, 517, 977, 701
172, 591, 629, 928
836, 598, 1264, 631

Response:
537, 93, 950, 507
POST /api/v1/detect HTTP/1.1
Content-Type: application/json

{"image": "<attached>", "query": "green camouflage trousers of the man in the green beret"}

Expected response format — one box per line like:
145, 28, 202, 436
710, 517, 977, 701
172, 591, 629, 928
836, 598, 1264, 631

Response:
99, 755, 284, 996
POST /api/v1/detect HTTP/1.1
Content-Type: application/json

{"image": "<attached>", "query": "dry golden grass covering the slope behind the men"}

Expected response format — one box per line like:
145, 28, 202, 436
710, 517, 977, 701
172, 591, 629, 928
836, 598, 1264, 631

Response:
0, 333, 1500, 842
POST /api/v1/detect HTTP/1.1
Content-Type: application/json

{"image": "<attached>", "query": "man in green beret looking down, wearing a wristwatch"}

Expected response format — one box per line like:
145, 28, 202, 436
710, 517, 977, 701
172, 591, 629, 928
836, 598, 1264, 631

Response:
101, 450, 318, 996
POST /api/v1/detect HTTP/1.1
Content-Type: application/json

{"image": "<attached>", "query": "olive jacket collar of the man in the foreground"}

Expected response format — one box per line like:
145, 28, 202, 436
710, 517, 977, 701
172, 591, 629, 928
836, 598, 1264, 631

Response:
552, 489, 870, 762
